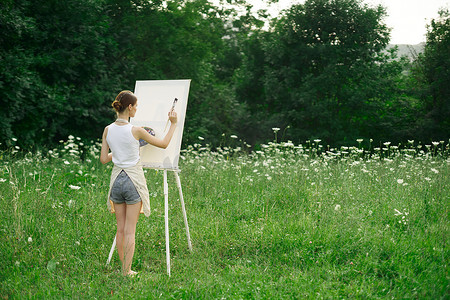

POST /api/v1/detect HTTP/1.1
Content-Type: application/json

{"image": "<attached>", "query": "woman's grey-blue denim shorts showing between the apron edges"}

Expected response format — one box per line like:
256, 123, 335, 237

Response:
109, 170, 141, 205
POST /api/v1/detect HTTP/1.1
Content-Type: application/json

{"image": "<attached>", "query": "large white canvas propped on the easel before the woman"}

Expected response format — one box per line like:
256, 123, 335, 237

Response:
131, 79, 191, 169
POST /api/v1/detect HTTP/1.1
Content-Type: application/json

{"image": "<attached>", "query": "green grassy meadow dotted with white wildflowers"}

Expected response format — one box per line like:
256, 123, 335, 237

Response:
0, 136, 450, 299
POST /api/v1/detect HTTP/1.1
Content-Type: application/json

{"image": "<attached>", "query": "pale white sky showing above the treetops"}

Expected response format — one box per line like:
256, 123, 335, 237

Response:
248, 0, 450, 45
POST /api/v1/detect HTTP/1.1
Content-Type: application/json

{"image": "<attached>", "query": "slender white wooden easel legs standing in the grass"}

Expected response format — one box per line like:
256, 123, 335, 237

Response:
106, 169, 192, 276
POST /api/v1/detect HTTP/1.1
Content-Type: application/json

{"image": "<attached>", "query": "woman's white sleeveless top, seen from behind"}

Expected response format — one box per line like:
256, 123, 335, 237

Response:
106, 123, 139, 168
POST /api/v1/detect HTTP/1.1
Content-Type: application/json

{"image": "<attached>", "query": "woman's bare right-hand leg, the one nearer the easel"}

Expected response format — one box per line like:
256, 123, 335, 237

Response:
122, 202, 141, 275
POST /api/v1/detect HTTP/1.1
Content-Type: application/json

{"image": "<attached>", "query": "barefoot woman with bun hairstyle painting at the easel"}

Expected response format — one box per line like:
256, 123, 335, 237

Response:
100, 91, 177, 276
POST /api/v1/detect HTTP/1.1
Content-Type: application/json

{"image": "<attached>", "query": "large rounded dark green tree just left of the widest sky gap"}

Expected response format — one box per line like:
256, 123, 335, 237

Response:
264, 0, 389, 143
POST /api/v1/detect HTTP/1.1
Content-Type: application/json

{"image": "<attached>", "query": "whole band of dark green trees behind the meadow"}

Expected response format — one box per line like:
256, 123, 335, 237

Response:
0, 0, 450, 149
